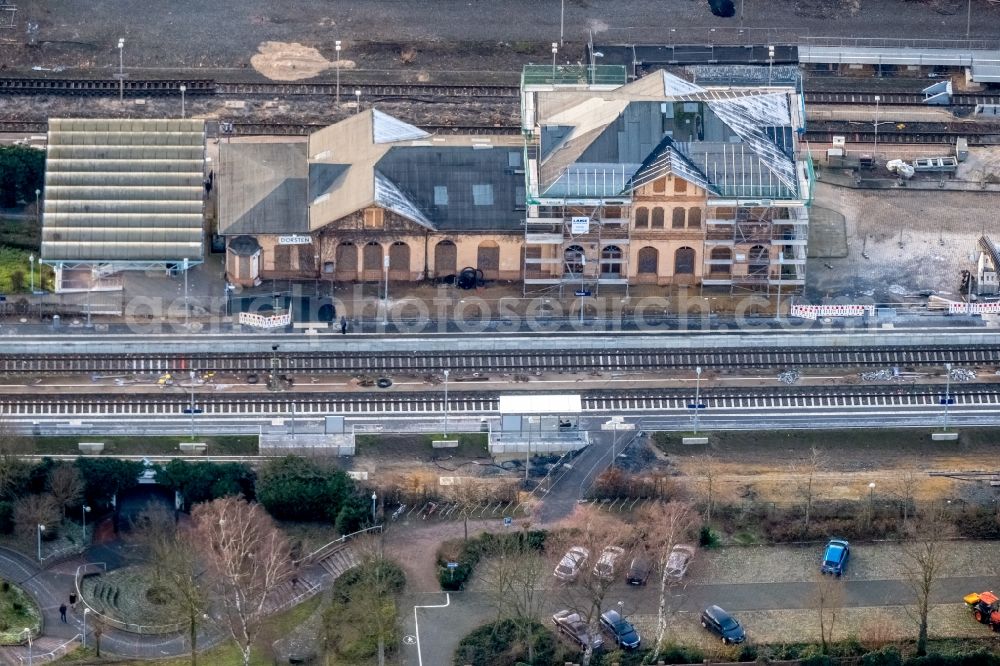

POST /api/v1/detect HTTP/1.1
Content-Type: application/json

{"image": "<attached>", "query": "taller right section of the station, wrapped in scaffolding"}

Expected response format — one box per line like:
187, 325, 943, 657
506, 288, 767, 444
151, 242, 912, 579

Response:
521, 66, 812, 294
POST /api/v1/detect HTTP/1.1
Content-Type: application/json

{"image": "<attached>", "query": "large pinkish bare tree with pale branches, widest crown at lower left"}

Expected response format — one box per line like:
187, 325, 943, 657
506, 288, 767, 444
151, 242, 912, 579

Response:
191, 497, 292, 666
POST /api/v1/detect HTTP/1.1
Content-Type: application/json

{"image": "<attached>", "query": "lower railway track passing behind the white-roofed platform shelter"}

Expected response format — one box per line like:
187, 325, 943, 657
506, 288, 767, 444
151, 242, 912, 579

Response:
0, 384, 1000, 417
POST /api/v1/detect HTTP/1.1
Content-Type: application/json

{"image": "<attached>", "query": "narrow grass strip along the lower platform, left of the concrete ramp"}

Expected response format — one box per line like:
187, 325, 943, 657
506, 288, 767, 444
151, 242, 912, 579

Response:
30, 435, 257, 458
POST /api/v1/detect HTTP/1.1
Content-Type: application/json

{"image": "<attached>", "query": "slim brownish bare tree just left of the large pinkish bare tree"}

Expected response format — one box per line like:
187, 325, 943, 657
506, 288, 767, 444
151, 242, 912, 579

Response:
133, 503, 209, 666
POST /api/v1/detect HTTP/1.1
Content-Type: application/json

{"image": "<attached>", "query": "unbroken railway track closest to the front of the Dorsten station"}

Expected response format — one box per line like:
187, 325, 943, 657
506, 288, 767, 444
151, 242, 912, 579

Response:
0, 345, 1000, 376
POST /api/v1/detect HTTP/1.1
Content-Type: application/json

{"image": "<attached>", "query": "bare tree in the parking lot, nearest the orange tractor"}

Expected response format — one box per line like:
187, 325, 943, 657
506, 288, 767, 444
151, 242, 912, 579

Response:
903, 505, 953, 656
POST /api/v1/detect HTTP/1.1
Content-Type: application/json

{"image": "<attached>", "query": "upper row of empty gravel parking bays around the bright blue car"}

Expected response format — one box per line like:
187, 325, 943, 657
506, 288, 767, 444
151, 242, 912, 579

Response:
689, 541, 1000, 583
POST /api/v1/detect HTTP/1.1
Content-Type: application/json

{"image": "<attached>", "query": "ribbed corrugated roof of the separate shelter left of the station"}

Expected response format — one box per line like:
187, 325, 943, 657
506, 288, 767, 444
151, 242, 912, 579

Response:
41, 119, 205, 262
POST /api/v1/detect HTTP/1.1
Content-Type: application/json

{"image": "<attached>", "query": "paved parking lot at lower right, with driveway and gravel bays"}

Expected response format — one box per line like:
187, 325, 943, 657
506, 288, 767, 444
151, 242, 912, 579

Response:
403, 541, 1000, 664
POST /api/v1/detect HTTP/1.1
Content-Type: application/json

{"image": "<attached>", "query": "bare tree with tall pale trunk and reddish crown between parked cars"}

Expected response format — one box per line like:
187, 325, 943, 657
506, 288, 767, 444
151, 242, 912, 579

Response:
639, 502, 699, 663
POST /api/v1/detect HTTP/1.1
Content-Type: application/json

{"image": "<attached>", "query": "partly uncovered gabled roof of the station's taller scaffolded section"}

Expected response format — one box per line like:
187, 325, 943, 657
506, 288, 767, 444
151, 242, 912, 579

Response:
533, 72, 798, 198
